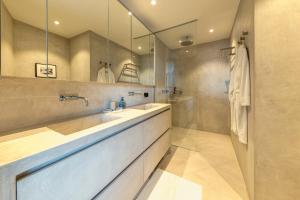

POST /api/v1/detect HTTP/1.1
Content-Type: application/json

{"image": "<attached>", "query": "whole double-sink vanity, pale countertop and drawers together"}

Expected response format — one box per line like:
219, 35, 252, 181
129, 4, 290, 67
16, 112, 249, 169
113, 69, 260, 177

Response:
0, 104, 171, 200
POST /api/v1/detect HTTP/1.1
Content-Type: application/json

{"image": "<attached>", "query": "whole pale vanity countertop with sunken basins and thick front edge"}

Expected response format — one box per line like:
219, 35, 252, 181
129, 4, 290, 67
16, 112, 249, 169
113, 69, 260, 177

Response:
0, 104, 170, 170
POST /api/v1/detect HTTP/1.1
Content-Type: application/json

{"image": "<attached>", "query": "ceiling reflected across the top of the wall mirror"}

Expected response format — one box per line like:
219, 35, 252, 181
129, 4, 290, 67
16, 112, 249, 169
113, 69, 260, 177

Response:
3, 0, 149, 54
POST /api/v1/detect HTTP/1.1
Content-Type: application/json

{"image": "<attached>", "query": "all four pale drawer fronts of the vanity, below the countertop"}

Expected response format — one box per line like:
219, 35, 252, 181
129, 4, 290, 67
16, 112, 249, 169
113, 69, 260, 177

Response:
17, 110, 171, 200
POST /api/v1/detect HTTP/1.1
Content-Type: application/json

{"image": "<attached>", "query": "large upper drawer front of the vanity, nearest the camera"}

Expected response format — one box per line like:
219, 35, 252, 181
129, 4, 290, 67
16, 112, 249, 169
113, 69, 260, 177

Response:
17, 124, 143, 200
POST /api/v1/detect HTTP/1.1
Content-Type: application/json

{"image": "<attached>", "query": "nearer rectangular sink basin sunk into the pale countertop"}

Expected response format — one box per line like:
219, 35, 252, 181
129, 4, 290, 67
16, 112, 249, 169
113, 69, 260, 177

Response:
47, 114, 121, 135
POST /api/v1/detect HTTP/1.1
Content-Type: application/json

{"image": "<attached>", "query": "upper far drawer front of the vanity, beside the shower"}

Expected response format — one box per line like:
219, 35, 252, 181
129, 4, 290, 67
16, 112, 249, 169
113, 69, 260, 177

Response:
143, 110, 171, 149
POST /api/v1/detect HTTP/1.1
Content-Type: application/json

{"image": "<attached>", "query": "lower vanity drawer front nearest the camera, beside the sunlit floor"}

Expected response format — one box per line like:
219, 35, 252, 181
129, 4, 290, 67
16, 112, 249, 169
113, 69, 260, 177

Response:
95, 157, 144, 200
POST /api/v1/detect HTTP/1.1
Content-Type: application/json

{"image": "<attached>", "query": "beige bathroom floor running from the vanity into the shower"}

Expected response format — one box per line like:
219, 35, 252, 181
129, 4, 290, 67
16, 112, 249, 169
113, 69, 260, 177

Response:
140, 127, 248, 200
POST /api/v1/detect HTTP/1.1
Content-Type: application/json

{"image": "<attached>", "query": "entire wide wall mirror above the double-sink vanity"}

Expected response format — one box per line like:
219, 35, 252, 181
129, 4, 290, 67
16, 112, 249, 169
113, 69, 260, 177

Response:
1, 0, 155, 85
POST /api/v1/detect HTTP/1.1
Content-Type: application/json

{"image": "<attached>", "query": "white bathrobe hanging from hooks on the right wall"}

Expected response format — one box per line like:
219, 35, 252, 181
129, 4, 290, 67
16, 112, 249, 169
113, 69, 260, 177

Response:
229, 45, 250, 144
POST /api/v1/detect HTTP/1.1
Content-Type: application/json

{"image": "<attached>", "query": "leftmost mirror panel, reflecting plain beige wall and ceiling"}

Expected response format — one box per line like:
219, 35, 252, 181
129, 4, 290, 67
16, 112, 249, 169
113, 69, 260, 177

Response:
1, 0, 47, 77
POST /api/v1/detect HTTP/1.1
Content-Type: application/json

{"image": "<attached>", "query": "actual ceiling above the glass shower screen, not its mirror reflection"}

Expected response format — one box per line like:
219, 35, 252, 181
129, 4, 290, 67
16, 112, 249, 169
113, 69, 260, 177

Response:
120, 0, 240, 49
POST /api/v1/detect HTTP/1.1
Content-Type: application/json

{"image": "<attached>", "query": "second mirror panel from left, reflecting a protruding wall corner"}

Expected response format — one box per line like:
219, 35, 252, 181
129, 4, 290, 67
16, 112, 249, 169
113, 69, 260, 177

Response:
48, 0, 108, 82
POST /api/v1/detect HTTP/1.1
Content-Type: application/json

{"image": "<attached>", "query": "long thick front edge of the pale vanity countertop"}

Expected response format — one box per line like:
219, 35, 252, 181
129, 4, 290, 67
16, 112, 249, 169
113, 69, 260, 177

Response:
0, 104, 171, 177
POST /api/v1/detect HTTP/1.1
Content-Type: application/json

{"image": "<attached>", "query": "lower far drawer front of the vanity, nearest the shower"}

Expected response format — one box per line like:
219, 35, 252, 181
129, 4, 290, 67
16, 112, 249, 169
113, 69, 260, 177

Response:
144, 131, 171, 181
